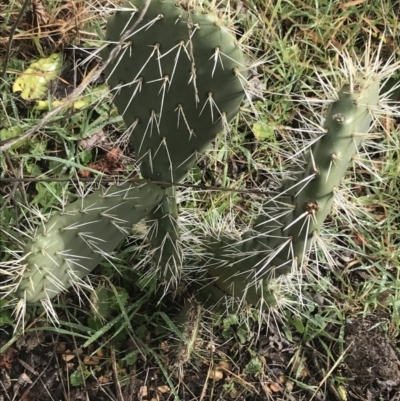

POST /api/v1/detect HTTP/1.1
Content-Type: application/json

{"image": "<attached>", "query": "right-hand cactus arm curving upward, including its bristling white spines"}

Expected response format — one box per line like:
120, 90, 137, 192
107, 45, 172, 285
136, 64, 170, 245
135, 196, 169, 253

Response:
200, 47, 398, 308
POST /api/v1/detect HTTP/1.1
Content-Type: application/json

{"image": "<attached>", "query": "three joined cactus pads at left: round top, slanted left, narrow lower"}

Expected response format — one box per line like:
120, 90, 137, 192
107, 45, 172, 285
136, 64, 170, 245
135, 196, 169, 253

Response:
1, 0, 247, 318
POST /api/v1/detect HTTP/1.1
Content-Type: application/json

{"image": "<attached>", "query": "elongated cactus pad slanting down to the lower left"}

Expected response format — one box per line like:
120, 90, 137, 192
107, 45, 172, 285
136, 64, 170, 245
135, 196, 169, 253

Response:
17, 180, 164, 302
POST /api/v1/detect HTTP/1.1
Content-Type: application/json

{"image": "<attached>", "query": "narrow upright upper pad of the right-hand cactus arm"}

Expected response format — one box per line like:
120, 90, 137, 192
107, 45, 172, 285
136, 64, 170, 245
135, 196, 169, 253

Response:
255, 78, 379, 266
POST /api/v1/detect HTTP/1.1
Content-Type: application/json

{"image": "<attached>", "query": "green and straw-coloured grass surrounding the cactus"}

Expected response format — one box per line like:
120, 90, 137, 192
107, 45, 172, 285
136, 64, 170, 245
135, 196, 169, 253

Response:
0, 0, 400, 401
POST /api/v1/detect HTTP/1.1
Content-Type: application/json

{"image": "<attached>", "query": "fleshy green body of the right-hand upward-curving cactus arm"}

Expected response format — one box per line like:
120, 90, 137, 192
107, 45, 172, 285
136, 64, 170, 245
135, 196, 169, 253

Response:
208, 75, 379, 305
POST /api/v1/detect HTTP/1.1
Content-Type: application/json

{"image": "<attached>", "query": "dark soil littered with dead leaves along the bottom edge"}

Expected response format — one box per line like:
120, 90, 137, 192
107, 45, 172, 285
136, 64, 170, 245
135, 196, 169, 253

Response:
0, 313, 400, 401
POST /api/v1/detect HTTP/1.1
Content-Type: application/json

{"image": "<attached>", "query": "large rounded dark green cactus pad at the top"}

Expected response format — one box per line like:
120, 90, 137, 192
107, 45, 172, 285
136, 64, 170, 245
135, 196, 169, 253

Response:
102, 0, 247, 182
